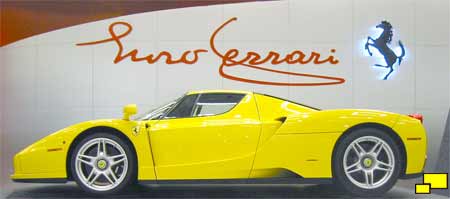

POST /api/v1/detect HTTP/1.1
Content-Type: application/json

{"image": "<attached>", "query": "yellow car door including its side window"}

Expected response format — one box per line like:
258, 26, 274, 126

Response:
149, 93, 261, 180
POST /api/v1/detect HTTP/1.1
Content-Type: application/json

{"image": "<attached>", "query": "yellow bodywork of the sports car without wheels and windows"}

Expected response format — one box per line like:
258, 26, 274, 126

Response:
11, 90, 426, 183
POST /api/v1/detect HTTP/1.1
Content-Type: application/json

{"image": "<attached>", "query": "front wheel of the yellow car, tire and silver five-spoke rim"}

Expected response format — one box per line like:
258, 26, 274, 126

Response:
70, 133, 136, 194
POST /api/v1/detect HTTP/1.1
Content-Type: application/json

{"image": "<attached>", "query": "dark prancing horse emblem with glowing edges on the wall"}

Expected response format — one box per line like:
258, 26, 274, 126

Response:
365, 21, 405, 80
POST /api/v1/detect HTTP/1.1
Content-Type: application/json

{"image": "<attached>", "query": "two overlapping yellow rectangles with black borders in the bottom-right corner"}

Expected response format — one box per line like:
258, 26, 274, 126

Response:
416, 173, 448, 194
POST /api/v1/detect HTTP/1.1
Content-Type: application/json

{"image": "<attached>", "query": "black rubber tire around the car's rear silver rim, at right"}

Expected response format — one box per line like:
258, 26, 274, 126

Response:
332, 128, 403, 197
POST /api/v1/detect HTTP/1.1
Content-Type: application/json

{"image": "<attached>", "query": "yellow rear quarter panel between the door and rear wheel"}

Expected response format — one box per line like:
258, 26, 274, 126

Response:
251, 94, 399, 178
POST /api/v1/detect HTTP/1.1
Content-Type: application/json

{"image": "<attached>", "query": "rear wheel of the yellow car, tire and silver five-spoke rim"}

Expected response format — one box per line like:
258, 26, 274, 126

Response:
333, 128, 402, 196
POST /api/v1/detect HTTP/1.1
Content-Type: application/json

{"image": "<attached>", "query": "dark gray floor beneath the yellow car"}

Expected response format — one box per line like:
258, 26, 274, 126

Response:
1, 183, 448, 199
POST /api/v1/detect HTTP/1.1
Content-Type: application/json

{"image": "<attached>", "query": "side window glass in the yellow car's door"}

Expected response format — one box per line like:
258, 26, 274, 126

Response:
193, 93, 245, 116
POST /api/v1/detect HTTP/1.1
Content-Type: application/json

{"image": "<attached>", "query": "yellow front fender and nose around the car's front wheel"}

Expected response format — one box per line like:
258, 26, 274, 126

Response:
11, 119, 155, 180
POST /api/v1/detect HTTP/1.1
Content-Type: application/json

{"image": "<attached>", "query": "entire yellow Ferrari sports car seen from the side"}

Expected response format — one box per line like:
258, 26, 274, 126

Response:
11, 90, 427, 196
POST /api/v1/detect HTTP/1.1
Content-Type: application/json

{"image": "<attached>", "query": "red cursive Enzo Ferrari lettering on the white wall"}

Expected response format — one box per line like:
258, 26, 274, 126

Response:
77, 17, 345, 86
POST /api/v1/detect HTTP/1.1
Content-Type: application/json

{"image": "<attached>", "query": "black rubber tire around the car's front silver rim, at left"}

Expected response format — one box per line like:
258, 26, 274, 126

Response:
70, 133, 137, 195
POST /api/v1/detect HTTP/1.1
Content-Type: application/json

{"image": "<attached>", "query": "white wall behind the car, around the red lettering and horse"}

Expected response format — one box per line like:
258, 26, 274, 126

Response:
2, 0, 450, 188
